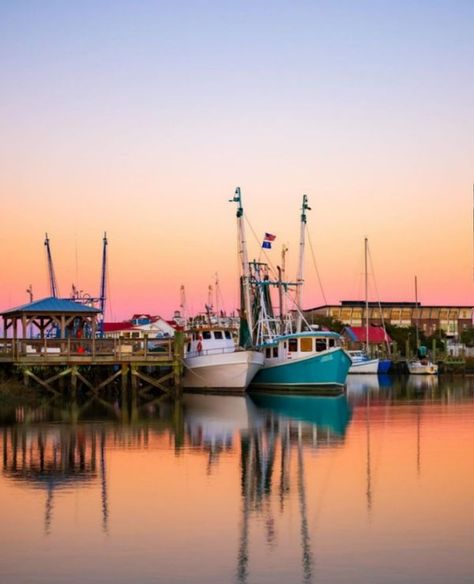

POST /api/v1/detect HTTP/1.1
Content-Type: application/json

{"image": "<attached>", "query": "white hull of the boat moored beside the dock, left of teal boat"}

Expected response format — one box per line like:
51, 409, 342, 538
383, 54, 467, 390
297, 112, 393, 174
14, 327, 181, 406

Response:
183, 351, 264, 391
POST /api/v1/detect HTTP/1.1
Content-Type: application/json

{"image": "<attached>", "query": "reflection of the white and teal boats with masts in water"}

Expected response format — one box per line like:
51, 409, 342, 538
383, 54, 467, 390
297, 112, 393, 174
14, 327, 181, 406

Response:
184, 393, 351, 583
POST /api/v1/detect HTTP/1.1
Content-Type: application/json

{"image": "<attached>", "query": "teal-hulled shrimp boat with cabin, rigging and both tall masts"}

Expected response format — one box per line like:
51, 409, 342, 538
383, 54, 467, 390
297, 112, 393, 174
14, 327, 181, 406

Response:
232, 189, 352, 392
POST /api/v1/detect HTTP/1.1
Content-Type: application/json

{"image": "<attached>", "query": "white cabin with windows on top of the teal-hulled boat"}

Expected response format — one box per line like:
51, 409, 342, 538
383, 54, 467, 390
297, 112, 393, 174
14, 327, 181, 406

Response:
261, 331, 341, 361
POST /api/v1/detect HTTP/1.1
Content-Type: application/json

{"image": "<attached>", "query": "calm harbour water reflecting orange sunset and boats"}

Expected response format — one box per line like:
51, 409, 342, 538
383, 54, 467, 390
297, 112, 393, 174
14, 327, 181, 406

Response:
0, 376, 474, 584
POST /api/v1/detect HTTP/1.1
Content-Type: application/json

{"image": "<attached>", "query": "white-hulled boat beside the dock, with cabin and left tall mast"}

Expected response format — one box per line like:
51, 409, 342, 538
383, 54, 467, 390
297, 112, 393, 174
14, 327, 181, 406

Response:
183, 189, 264, 391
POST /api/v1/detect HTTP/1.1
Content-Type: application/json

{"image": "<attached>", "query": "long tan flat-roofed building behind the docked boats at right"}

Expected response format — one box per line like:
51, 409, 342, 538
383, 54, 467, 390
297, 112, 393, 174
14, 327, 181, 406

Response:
304, 300, 474, 338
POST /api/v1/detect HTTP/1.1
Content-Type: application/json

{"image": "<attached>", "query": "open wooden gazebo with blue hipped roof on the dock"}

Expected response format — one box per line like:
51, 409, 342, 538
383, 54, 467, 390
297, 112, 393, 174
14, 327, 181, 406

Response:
1, 296, 100, 339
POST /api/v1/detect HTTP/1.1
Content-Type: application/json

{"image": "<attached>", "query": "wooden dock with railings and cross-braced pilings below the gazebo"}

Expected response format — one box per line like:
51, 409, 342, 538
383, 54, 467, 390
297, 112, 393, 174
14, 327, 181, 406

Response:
0, 332, 184, 394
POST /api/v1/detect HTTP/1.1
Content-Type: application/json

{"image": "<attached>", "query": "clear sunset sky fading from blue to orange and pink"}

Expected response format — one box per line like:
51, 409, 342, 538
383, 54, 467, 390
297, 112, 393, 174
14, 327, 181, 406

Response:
0, 0, 474, 320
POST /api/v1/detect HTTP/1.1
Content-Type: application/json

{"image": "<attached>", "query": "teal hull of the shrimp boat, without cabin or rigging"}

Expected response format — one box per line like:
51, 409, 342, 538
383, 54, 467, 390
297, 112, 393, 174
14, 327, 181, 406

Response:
252, 349, 352, 389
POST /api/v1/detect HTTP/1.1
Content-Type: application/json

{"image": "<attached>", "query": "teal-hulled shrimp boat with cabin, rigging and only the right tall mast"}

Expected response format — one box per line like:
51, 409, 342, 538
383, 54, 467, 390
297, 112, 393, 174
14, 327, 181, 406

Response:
241, 195, 351, 391
